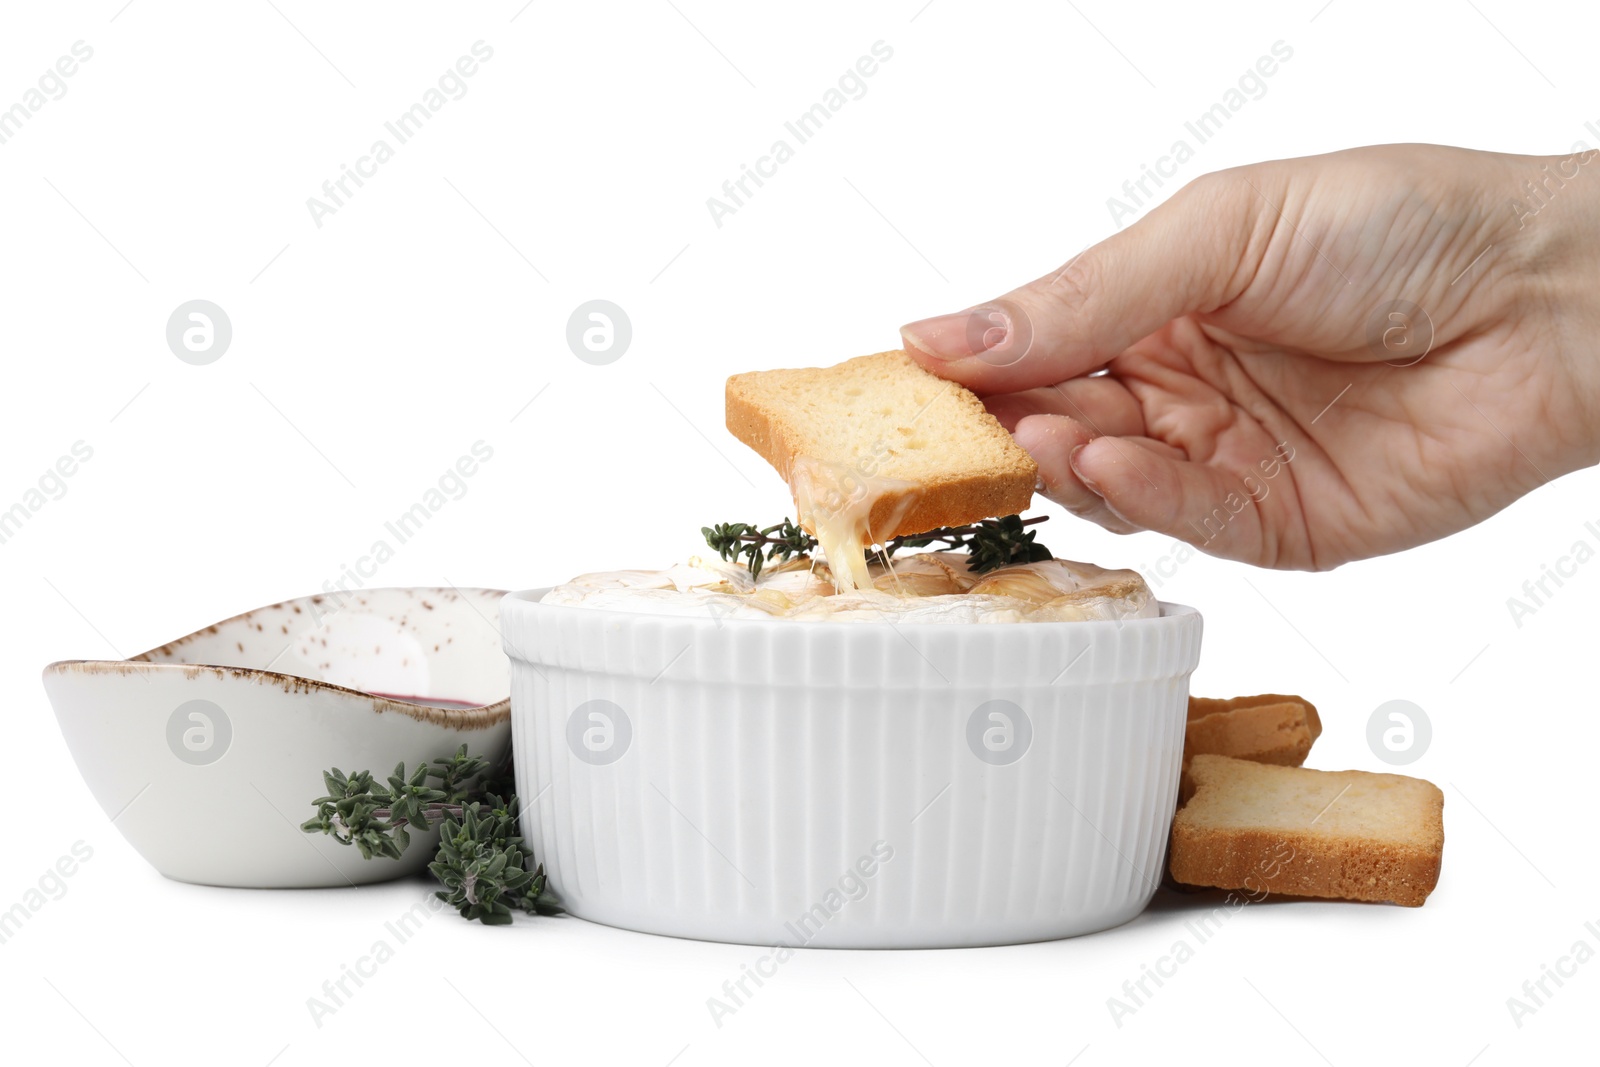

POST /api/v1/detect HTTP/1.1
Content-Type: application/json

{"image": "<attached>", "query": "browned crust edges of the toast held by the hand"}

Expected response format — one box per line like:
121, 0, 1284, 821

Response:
726, 350, 1038, 542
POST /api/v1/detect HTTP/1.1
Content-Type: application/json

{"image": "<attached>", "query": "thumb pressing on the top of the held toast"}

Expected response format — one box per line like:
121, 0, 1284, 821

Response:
901, 168, 1274, 395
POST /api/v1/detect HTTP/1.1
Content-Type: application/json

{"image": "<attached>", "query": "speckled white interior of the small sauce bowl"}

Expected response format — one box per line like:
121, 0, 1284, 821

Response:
143, 589, 509, 707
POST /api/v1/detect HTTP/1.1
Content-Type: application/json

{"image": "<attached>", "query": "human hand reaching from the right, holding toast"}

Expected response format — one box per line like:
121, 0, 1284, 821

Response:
901, 146, 1600, 569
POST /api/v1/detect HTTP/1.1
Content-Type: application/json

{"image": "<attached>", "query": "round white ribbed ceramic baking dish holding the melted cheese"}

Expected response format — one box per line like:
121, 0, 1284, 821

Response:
501, 590, 1200, 949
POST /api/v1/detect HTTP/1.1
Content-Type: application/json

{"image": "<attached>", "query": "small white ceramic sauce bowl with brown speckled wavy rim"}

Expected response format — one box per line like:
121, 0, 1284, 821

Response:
45, 589, 510, 888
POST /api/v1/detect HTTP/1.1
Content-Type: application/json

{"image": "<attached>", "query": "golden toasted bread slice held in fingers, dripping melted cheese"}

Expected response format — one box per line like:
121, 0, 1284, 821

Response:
728, 350, 1038, 544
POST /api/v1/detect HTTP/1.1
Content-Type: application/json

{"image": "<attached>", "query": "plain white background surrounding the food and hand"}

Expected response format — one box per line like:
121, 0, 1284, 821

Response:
0, 0, 1600, 1067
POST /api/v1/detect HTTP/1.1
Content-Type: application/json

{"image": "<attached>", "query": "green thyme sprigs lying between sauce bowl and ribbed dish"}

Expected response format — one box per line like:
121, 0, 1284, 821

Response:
301, 745, 558, 926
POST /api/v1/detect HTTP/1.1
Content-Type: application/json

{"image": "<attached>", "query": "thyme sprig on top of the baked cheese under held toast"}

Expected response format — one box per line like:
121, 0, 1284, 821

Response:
701, 515, 1054, 577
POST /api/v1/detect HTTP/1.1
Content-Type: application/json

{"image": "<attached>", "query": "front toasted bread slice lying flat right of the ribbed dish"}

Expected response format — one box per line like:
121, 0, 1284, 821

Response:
1168, 755, 1445, 907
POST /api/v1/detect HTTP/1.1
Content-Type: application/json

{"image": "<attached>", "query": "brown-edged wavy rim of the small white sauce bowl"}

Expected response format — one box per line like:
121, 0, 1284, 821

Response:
45, 585, 510, 729
